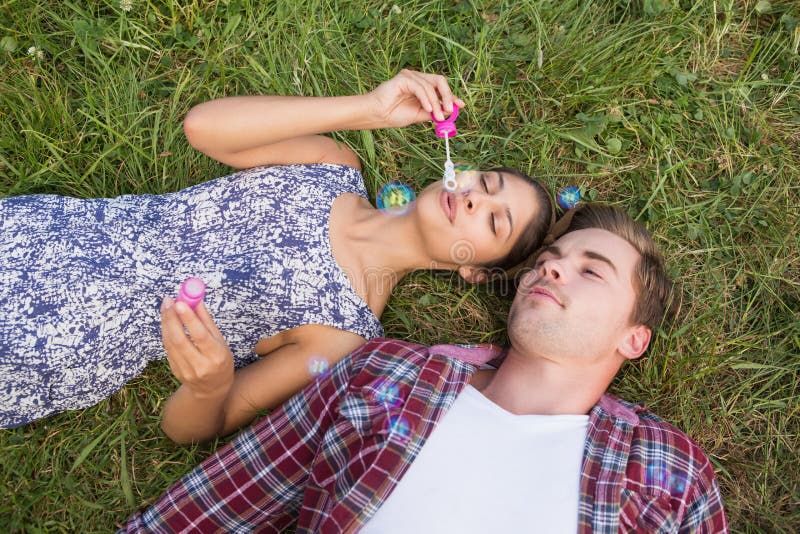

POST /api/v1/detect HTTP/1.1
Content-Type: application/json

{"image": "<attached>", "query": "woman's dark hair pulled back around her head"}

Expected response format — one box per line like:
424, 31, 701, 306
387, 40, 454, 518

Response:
482, 167, 555, 274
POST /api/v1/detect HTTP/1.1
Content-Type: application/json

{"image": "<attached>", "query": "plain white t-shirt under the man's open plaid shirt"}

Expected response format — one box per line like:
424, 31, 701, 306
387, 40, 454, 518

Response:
361, 386, 589, 534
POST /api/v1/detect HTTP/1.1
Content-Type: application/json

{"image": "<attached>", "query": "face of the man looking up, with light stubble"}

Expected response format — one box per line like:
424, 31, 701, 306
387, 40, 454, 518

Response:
508, 228, 649, 367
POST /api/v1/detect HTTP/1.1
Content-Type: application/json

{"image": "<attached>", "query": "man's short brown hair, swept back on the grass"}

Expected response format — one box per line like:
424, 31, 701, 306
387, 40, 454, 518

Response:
562, 203, 675, 331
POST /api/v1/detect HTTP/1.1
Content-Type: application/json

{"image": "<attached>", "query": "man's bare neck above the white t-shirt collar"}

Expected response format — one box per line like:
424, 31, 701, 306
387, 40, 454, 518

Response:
476, 348, 616, 415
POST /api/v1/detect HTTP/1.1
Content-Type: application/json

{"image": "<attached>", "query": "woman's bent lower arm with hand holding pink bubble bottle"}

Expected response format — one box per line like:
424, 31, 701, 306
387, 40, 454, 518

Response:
161, 301, 364, 443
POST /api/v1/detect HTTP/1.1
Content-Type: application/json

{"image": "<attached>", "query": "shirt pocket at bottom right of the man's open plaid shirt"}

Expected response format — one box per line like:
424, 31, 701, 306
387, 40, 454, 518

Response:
619, 488, 678, 534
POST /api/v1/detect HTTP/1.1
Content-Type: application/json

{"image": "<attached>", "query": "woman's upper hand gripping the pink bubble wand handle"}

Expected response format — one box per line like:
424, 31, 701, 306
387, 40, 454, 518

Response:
369, 69, 464, 128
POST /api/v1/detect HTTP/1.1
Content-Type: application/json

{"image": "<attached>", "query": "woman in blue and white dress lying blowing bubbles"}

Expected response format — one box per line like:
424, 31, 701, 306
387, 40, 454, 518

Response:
0, 71, 552, 442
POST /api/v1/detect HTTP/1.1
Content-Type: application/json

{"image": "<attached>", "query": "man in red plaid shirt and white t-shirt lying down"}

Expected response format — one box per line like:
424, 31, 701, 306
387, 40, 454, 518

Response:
122, 205, 727, 533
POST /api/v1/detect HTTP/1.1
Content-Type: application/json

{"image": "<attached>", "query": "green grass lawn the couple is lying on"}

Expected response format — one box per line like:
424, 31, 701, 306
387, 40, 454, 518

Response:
0, 0, 800, 532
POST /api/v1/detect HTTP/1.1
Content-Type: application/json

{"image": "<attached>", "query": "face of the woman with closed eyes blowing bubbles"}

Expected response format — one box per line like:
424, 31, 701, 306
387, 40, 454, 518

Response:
416, 170, 541, 265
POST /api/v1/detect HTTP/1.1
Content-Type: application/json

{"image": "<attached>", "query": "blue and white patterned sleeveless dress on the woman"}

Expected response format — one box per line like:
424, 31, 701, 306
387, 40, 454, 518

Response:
0, 164, 383, 428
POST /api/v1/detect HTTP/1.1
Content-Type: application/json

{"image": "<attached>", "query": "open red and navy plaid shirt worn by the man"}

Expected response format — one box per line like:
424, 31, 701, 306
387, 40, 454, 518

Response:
122, 339, 727, 533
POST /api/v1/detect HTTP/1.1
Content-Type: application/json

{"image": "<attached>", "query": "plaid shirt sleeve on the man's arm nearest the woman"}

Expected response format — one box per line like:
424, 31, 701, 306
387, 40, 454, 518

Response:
119, 356, 352, 532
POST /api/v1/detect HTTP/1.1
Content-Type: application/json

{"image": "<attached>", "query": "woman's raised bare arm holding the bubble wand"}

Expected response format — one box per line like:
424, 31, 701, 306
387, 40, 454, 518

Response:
183, 70, 464, 168
